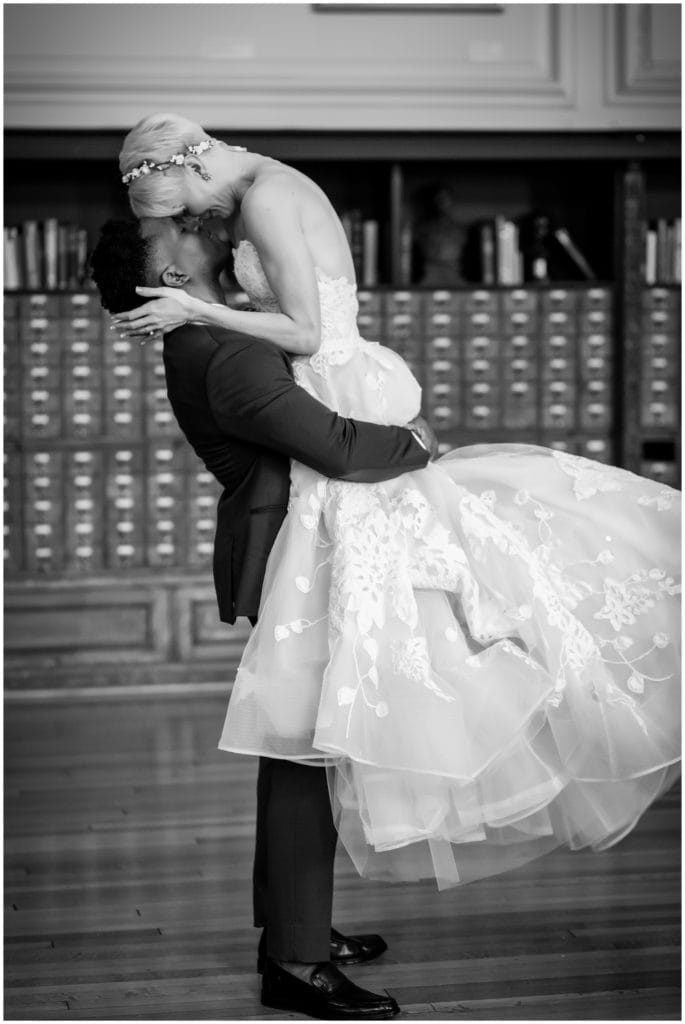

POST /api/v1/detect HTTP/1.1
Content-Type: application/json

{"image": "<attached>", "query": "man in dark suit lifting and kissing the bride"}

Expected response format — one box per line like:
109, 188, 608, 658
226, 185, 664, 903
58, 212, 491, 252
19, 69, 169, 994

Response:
91, 218, 432, 1020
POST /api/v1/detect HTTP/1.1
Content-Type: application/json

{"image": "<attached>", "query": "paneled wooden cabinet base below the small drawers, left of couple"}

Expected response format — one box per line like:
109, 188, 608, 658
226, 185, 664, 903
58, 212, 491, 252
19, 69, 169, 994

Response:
4, 573, 250, 693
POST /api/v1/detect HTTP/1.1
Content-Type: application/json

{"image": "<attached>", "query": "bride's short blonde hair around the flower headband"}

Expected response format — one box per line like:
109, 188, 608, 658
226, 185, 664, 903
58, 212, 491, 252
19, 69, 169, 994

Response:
119, 114, 210, 217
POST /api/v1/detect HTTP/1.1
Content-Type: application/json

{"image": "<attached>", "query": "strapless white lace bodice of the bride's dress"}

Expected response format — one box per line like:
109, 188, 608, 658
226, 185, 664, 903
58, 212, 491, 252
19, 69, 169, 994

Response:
233, 239, 359, 351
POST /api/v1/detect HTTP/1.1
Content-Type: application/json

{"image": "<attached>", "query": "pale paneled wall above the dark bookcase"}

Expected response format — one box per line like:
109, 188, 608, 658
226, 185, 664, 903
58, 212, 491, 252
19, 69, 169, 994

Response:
5, 3, 680, 131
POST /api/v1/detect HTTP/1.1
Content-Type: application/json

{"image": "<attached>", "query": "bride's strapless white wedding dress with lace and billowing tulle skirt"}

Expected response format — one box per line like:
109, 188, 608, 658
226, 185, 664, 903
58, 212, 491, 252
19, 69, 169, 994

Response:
219, 242, 681, 887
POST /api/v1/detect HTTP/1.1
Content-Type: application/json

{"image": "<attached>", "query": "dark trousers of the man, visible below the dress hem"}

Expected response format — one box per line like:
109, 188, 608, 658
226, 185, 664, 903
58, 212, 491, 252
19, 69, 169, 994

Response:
253, 758, 337, 964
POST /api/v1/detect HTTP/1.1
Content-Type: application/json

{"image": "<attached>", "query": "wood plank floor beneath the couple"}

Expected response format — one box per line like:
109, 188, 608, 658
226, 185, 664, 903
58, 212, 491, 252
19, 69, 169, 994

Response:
5, 694, 681, 1020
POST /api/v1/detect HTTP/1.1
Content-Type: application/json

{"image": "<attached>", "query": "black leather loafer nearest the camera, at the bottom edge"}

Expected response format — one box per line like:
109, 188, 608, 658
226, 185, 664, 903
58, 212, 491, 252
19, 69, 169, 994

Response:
262, 957, 399, 1021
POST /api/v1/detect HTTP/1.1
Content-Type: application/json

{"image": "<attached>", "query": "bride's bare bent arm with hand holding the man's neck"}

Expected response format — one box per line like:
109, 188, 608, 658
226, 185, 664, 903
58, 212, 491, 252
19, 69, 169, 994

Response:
115, 183, 320, 355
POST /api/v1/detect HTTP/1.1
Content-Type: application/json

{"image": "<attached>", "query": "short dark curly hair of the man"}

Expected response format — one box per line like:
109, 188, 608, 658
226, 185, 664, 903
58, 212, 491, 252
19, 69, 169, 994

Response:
90, 219, 152, 313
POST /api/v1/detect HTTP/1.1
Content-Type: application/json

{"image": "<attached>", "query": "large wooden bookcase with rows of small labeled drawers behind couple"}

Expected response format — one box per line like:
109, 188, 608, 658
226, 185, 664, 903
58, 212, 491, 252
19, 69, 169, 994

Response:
4, 132, 680, 688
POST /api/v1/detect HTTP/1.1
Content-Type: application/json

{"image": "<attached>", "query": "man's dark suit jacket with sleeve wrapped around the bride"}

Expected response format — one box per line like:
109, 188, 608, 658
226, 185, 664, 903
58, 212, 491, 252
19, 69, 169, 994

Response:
164, 325, 429, 623
